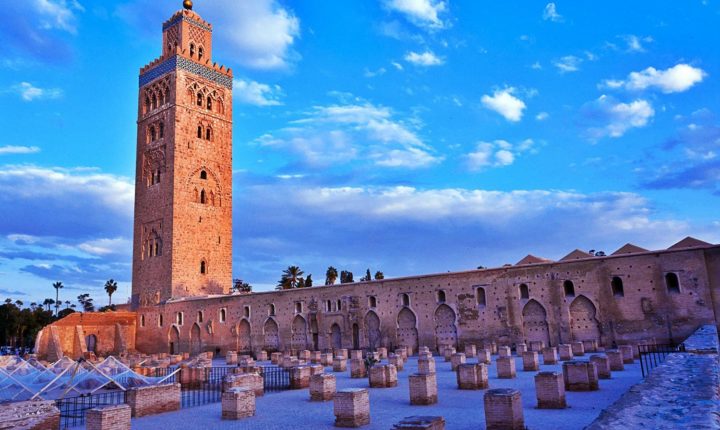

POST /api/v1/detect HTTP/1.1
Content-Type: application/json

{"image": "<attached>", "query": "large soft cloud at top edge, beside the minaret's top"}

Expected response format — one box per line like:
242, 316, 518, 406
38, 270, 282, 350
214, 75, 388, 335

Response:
212, 0, 300, 69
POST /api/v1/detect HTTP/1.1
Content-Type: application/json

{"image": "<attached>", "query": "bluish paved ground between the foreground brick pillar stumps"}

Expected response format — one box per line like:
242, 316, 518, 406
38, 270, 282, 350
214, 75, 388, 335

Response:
115, 357, 641, 430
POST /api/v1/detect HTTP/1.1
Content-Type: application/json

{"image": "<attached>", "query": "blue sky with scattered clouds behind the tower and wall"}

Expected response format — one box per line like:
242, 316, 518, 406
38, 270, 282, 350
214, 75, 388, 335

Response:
0, 0, 720, 304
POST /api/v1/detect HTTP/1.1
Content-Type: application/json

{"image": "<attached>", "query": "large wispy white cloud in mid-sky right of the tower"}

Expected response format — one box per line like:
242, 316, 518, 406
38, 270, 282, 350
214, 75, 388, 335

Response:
257, 103, 443, 168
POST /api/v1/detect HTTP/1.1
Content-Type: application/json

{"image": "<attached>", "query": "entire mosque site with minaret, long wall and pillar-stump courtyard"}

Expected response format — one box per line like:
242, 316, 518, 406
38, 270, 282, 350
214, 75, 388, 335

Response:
0, 0, 720, 429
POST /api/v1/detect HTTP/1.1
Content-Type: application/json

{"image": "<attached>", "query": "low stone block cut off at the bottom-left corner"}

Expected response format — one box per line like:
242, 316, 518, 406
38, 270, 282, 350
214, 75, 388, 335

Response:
0, 400, 60, 430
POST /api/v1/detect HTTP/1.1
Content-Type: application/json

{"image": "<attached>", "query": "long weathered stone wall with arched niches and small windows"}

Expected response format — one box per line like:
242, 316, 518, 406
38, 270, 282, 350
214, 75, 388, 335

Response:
132, 246, 720, 353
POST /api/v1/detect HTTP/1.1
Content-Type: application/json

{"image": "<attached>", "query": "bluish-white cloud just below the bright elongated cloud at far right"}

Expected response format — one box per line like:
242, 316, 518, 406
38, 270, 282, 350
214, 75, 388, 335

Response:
585, 95, 655, 138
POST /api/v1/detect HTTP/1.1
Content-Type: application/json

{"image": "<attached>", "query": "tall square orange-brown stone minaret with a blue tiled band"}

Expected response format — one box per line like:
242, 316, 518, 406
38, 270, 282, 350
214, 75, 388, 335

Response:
132, 0, 232, 308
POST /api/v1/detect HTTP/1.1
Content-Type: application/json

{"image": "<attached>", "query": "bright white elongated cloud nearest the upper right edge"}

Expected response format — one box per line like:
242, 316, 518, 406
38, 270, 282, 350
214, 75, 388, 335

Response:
625, 64, 707, 94
